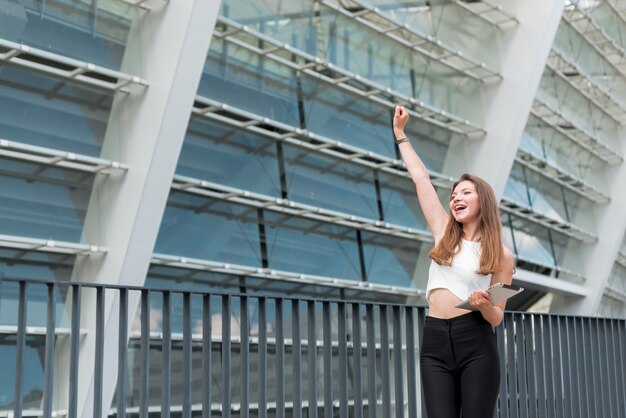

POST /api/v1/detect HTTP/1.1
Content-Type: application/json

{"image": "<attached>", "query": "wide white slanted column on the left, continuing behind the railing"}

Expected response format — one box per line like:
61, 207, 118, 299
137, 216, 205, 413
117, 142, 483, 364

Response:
56, 0, 220, 418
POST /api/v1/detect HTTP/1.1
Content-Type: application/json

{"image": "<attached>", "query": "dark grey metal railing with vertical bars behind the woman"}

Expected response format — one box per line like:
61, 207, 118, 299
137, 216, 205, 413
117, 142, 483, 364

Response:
0, 279, 626, 418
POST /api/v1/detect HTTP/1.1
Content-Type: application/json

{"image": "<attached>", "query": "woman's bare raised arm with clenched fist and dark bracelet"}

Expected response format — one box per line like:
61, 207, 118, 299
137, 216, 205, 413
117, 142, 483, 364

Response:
393, 106, 448, 240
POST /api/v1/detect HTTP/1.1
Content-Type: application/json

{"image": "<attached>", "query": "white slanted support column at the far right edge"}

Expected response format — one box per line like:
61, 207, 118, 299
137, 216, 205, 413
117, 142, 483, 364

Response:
550, 125, 626, 315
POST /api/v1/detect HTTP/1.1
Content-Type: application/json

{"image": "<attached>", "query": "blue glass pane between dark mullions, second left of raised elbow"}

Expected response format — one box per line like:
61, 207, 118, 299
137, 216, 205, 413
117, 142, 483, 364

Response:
283, 145, 379, 219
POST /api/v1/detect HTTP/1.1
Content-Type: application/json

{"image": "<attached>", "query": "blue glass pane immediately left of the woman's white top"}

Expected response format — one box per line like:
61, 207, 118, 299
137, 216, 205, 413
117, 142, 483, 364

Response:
362, 232, 424, 288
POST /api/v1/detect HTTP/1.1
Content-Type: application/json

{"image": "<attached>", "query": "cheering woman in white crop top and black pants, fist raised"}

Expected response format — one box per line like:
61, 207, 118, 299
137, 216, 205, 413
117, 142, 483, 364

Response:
393, 106, 514, 418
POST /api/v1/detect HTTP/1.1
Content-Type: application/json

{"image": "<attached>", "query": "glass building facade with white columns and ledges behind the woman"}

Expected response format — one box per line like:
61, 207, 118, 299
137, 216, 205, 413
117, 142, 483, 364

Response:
0, 0, 626, 413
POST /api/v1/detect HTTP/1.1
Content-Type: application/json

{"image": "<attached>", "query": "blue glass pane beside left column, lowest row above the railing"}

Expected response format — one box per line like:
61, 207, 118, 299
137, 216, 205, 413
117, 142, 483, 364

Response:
155, 192, 261, 266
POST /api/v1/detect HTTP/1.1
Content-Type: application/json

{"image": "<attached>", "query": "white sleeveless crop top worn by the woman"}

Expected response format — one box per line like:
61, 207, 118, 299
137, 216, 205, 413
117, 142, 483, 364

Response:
426, 240, 491, 300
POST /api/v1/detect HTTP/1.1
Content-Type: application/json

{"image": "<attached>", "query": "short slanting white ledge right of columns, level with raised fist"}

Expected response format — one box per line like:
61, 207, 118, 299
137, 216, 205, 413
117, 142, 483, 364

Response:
531, 98, 624, 164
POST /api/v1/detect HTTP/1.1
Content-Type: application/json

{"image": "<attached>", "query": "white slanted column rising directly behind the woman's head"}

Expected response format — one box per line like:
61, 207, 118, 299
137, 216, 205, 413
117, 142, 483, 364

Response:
443, 0, 564, 199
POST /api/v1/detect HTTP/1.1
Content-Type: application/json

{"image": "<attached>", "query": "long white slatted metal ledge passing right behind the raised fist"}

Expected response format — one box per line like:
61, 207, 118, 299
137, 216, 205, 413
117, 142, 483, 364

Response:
214, 16, 485, 138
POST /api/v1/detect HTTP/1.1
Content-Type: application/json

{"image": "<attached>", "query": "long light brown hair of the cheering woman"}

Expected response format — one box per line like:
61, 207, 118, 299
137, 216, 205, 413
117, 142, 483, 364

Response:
428, 174, 504, 275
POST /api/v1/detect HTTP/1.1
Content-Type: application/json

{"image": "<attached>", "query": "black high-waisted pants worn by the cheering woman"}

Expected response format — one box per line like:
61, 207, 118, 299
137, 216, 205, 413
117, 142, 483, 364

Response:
420, 312, 500, 418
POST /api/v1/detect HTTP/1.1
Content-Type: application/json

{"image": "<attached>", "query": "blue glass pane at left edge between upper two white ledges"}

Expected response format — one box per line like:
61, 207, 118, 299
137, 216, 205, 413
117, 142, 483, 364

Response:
0, 65, 112, 157
